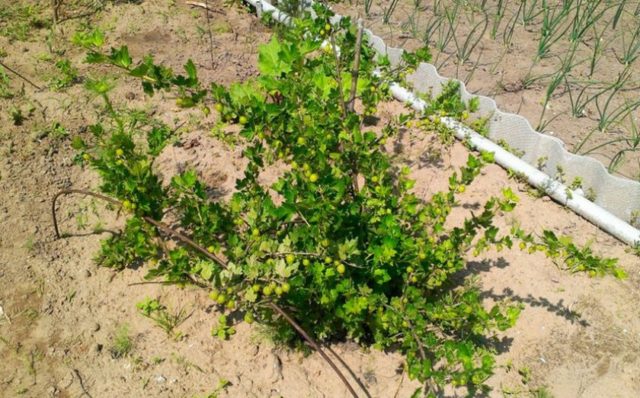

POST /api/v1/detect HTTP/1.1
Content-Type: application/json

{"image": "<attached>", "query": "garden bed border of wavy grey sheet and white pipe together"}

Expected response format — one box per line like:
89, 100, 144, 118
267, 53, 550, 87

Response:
245, 0, 640, 246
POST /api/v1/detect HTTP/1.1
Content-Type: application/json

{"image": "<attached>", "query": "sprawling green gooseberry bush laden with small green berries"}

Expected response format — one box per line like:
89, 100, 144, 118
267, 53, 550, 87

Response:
62, 6, 624, 394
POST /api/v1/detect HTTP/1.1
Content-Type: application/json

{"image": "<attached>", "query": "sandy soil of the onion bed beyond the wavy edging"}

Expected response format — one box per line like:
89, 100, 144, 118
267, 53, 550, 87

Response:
332, 0, 640, 180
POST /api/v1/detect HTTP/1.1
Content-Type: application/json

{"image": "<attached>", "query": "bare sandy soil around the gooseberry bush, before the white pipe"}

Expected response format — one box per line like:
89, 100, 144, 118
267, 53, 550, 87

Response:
0, 0, 640, 397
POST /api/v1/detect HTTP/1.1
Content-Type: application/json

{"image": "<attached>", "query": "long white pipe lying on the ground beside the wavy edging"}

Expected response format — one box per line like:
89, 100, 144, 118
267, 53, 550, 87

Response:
245, 0, 640, 246
